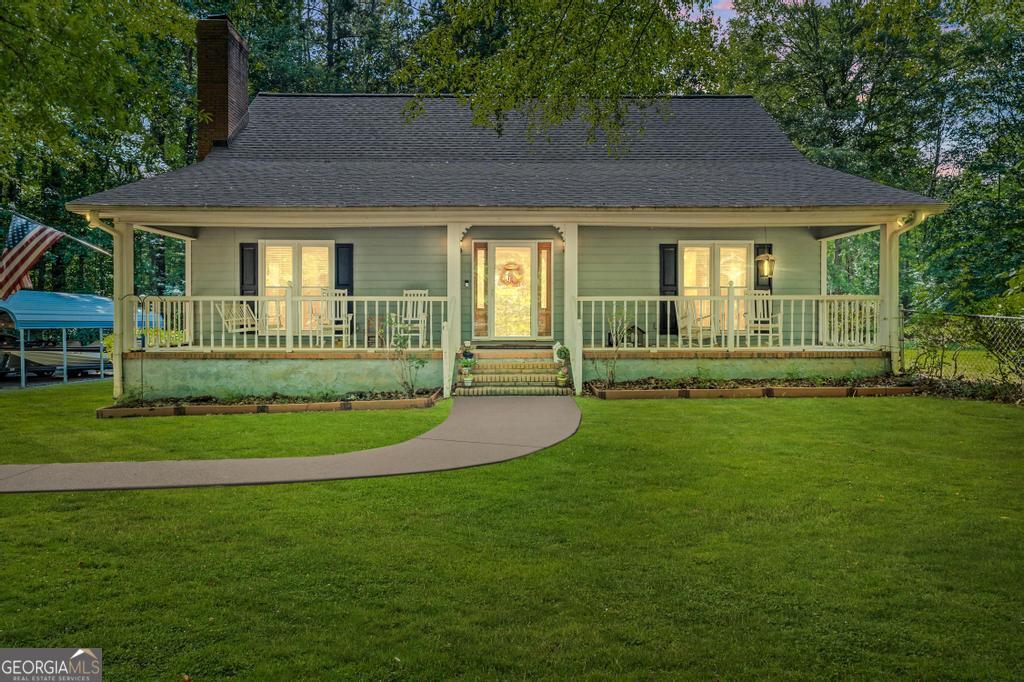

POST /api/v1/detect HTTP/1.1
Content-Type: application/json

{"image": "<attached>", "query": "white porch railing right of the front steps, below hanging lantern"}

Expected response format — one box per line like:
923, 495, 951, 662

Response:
577, 288, 884, 350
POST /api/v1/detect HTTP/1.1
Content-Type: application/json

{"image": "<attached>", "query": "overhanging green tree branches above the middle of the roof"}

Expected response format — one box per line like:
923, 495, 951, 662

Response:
397, 0, 714, 146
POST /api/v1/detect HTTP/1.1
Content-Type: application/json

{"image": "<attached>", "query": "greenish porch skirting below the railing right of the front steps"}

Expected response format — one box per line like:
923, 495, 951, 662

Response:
583, 350, 891, 381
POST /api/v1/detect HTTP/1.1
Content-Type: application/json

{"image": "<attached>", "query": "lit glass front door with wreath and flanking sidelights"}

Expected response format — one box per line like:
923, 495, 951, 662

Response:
473, 240, 553, 340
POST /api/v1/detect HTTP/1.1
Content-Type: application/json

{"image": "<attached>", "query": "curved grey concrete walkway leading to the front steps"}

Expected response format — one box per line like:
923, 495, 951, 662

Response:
0, 396, 580, 493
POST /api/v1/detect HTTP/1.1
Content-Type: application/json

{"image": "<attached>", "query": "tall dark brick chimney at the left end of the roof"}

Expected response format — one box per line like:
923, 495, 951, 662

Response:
196, 14, 249, 161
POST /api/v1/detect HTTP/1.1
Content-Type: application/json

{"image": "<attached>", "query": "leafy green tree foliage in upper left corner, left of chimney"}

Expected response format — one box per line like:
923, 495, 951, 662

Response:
0, 0, 189, 184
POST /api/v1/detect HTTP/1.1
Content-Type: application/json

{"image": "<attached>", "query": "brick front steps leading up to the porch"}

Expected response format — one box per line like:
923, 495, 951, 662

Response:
455, 349, 572, 395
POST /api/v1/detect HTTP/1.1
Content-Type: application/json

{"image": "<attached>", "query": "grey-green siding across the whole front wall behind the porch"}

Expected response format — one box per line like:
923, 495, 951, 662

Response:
186, 226, 820, 340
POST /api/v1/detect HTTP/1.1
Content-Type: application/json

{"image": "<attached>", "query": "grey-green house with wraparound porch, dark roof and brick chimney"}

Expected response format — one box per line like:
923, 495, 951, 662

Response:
61, 17, 945, 397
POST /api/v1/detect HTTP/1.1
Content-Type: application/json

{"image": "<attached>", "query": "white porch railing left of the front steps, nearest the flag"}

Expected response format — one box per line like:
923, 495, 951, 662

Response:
125, 294, 450, 351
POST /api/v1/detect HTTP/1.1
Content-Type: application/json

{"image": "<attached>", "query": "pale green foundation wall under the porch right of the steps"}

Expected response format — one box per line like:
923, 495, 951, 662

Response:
583, 357, 890, 381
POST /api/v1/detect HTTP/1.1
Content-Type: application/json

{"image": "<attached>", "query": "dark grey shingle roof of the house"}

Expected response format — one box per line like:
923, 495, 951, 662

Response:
71, 94, 936, 208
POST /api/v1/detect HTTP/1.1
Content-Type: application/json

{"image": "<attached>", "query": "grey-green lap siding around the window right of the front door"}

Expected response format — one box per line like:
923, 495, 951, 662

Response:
580, 226, 821, 296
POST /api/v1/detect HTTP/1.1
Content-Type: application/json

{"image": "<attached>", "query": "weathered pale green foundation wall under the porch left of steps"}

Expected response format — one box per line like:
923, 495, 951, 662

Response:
124, 358, 442, 399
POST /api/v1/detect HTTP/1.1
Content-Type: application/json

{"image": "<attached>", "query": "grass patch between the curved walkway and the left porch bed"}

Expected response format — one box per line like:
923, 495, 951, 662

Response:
0, 382, 450, 464
